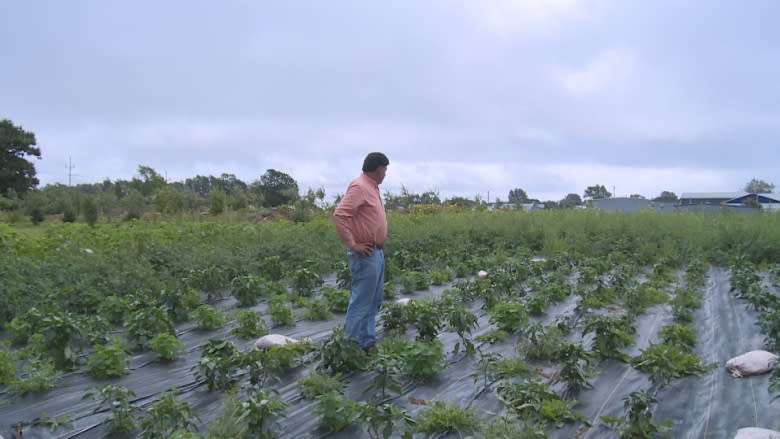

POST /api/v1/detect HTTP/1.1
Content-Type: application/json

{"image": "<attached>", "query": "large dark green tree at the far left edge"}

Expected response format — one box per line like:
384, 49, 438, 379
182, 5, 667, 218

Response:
0, 119, 41, 195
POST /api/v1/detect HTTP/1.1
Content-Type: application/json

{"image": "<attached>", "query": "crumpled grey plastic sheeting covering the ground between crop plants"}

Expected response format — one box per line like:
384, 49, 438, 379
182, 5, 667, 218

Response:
0, 267, 780, 439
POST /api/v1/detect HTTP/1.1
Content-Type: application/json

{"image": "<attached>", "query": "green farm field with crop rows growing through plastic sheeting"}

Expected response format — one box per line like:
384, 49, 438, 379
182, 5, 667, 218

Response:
0, 210, 780, 438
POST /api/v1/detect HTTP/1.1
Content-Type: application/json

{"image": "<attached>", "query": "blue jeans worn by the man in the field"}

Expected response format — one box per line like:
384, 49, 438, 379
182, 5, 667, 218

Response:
345, 248, 385, 348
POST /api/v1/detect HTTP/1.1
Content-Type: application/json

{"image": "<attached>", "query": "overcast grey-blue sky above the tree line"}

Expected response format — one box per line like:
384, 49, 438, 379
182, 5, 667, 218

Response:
0, 0, 780, 201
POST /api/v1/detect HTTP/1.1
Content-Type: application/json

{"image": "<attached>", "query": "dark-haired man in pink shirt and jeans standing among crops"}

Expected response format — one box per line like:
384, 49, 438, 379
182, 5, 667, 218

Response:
333, 152, 390, 352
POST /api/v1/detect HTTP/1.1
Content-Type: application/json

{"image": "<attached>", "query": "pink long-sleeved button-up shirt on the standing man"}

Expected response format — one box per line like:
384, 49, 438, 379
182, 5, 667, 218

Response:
333, 174, 387, 248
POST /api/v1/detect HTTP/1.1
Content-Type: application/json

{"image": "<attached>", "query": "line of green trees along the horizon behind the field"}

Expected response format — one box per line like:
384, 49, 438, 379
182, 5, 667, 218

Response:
0, 119, 775, 224
